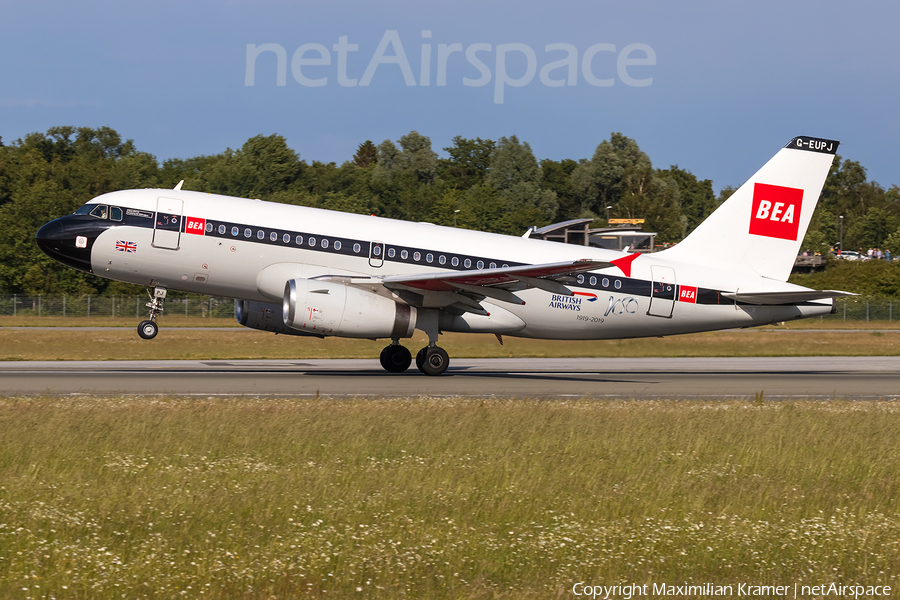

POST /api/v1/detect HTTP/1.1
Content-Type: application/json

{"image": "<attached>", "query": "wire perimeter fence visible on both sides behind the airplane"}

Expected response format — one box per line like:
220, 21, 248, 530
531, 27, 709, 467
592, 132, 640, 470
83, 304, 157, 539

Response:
0, 295, 900, 322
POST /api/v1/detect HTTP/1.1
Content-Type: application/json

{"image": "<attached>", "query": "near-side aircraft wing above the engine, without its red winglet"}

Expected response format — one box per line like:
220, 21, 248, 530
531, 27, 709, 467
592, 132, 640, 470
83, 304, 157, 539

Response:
353, 259, 613, 314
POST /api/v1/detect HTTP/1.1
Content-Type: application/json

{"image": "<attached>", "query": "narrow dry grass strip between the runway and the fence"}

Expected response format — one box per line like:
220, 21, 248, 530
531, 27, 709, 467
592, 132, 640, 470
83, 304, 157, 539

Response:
0, 327, 900, 360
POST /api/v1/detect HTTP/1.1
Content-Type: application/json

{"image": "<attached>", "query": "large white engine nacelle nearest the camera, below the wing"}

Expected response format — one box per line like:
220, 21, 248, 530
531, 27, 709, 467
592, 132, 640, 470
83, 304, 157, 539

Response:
283, 279, 416, 338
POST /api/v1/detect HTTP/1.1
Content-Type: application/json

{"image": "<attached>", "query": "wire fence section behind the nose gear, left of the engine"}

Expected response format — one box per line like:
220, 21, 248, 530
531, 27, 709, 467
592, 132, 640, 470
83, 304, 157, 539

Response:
0, 295, 235, 319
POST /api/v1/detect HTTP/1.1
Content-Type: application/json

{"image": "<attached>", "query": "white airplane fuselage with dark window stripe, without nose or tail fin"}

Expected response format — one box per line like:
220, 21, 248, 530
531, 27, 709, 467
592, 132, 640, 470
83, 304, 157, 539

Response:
91, 190, 832, 340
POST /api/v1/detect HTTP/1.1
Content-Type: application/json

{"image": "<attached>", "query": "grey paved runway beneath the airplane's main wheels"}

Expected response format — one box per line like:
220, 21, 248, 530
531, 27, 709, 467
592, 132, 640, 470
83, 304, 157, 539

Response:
0, 357, 900, 399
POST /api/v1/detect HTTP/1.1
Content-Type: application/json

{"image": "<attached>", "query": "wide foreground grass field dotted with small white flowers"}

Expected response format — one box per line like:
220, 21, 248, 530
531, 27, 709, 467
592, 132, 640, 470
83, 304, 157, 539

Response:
0, 397, 900, 599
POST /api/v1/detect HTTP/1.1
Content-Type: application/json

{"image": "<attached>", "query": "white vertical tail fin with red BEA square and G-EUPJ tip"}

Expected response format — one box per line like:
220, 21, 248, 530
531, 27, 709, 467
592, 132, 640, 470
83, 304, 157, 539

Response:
662, 136, 839, 281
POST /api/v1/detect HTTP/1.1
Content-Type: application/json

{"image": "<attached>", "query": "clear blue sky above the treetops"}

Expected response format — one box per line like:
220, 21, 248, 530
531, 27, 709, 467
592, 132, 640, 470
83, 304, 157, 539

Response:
0, 0, 900, 190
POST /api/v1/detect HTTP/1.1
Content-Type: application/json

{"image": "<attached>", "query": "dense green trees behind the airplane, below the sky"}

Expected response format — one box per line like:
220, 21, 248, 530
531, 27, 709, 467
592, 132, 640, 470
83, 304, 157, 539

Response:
0, 126, 900, 294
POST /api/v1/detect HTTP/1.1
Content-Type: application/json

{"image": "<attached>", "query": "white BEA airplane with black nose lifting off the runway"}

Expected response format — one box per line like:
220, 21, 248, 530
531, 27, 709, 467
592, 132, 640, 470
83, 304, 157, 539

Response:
36, 136, 853, 376
